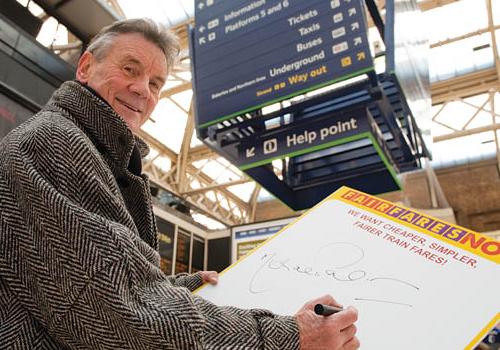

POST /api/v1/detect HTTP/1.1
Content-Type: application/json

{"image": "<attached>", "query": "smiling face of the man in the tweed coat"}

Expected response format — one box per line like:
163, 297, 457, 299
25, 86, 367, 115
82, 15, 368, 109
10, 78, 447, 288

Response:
76, 33, 168, 131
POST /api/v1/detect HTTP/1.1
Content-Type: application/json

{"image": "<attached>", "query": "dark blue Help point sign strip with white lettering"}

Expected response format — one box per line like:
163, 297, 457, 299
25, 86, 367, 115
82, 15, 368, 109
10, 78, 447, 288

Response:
238, 108, 371, 169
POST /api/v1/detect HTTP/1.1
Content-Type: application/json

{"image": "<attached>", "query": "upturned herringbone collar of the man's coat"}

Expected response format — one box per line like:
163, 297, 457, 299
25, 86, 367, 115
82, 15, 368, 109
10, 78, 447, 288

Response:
44, 81, 149, 174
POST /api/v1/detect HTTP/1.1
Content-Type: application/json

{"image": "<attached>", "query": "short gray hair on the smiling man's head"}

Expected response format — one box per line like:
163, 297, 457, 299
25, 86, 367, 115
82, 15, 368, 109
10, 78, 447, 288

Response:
87, 18, 179, 71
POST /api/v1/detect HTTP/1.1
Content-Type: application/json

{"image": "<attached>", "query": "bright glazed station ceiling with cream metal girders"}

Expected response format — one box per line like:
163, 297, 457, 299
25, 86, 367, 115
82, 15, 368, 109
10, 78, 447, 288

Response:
18, 0, 500, 228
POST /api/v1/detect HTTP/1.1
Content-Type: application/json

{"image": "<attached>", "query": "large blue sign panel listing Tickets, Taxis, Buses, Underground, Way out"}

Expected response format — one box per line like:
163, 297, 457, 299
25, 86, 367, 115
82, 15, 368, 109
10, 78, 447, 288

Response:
193, 0, 373, 127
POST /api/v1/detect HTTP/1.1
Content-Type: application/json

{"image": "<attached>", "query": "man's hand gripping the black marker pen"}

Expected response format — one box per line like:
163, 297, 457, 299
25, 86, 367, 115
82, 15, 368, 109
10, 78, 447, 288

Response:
295, 295, 359, 350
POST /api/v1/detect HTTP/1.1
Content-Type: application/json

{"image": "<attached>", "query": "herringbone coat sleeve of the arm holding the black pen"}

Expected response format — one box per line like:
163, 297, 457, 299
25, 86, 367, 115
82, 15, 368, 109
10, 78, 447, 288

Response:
0, 118, 299, 350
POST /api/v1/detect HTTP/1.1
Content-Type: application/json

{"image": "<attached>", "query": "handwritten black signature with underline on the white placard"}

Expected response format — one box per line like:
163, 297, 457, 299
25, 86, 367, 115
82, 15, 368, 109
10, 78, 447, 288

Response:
249, 242, 420, 307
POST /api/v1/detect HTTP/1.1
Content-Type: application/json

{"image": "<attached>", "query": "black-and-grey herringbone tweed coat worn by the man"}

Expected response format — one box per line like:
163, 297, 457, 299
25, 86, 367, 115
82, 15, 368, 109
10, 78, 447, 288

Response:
0, 82, 299, 350
